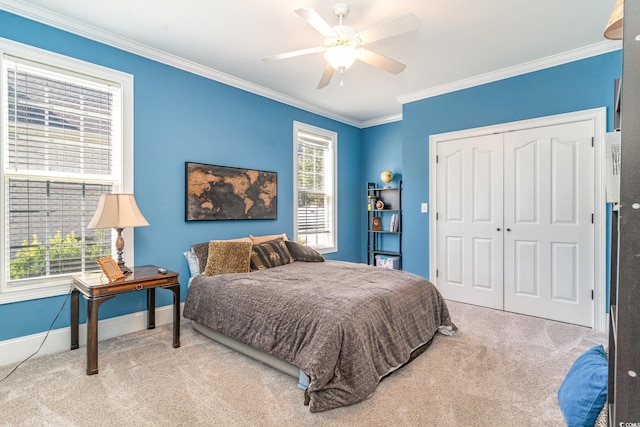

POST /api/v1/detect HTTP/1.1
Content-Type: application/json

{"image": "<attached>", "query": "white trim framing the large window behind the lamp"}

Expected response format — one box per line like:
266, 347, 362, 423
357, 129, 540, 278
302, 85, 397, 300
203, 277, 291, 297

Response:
0, 38, 135, 304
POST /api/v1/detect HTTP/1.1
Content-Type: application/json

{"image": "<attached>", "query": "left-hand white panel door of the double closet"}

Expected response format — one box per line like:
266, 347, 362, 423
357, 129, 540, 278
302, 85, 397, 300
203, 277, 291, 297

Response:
436, 135, 503, 309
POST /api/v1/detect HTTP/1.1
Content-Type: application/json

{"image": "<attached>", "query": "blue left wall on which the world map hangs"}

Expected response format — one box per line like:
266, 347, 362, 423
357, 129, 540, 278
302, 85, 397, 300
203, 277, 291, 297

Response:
0, 11, 363, 341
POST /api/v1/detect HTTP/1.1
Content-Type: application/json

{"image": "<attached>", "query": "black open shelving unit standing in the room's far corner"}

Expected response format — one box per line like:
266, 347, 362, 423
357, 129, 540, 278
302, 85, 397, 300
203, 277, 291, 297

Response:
367, 181, 402, 269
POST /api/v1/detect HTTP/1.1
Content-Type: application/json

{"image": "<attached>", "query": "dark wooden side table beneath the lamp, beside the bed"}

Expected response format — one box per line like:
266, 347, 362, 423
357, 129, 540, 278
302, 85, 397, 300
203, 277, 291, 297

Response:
71, 265, 180, 375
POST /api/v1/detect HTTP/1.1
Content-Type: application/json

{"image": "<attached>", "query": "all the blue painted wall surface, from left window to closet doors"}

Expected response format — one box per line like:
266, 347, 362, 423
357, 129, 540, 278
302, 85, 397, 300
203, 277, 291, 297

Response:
0, 11, 621, 341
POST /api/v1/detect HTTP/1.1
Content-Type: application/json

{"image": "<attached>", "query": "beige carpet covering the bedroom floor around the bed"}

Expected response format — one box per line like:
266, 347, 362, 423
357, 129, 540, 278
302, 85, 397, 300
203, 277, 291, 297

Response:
0, 302, 606, 427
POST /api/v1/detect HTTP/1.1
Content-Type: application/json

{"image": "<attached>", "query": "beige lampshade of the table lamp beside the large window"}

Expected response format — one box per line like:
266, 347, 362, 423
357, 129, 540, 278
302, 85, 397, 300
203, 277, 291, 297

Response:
87, 194, 149, 228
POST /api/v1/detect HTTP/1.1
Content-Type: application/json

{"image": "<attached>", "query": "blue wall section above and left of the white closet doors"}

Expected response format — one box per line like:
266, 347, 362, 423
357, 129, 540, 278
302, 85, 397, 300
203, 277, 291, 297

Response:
402, 51, 622, 278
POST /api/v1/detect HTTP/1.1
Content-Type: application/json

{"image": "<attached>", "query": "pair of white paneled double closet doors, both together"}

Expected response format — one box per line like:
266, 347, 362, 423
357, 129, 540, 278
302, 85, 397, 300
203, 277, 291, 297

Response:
436, 121, 595, 326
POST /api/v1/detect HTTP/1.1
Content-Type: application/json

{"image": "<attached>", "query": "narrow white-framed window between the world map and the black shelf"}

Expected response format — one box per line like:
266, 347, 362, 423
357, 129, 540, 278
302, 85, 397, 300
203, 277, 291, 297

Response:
293, 122, 338, 253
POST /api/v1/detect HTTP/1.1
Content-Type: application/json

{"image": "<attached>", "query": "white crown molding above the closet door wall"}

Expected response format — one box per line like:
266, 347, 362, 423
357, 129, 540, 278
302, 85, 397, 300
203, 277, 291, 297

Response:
396, 41, 622, 104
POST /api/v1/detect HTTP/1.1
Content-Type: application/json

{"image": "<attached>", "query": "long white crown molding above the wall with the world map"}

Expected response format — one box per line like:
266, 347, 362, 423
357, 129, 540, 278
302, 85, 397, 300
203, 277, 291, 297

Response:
0, 0, 362, 128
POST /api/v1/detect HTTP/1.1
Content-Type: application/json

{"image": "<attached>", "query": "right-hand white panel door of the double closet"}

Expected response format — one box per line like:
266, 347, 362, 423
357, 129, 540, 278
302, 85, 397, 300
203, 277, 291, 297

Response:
504, 121, 595, 326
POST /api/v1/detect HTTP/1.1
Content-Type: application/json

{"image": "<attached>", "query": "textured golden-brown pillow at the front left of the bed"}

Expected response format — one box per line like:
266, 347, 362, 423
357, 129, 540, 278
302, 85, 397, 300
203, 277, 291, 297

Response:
204, 240, 253, 276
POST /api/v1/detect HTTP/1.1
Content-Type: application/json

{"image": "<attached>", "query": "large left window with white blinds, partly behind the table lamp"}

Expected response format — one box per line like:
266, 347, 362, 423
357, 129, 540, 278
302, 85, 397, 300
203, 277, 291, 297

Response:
0, 41, 131, 302
